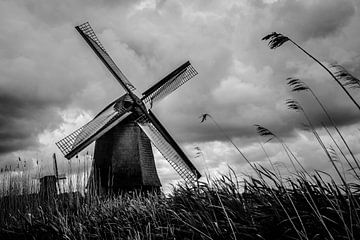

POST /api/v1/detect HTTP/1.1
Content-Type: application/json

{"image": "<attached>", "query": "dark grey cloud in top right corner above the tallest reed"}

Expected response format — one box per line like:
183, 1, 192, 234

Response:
272, 0, 355, 41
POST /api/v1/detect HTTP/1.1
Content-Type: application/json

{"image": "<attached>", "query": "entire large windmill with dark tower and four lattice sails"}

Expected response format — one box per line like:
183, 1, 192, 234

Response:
56, 23, 201, 193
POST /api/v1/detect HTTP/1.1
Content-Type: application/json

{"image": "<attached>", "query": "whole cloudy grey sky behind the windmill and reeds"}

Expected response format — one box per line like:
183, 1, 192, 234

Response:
0, 0, 360, 188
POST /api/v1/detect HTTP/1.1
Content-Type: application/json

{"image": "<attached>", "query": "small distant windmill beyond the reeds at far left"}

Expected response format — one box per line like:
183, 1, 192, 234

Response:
39, 153, 66, 198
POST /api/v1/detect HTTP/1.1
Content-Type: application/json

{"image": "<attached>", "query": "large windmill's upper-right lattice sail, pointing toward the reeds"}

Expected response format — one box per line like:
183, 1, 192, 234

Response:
142, 61, 198, 104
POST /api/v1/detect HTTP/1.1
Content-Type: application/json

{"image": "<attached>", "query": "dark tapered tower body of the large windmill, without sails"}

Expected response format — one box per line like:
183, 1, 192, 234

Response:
92, 114, 161, 193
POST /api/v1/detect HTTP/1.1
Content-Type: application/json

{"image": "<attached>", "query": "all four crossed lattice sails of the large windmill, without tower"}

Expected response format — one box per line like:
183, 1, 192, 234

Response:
56, 22, 201, 193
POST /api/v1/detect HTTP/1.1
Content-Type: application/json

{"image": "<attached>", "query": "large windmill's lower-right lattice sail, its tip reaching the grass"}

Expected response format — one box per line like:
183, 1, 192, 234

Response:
137, 111, 201, 182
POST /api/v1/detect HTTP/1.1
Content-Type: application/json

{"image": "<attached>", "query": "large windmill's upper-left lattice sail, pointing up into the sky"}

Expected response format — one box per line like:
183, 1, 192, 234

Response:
75, 22, 135, 92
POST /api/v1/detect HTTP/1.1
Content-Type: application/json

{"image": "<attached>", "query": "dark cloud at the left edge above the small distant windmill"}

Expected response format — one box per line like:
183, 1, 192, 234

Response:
0, 89, 61, 155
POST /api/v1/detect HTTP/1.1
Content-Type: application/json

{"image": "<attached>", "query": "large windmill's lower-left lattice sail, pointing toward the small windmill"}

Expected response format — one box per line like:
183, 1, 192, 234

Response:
56, 101, 131, 159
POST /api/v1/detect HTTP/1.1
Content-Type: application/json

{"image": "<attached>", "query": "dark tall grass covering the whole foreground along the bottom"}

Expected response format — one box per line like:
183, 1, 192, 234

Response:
0, 167, 360, 239
